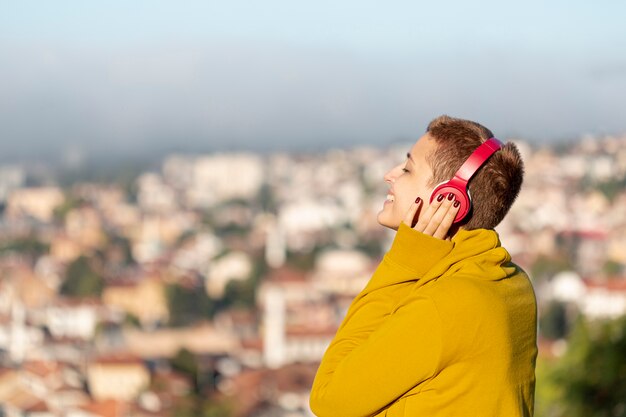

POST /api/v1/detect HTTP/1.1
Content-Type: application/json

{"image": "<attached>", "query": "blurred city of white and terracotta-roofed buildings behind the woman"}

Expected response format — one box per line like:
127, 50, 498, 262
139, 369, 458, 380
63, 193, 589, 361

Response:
0, 136, 626, 417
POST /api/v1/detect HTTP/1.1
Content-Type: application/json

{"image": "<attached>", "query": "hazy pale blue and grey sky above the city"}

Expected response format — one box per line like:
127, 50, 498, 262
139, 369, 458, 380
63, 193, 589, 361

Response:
0, 0, 626, 160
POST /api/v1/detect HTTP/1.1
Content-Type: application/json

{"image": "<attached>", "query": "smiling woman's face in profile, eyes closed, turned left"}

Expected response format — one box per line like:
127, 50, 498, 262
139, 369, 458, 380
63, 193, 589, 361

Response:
377, 133, 437, 230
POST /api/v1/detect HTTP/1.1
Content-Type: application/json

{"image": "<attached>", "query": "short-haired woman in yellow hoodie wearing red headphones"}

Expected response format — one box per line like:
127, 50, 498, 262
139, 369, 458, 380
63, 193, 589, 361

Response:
310, 116, 537, 417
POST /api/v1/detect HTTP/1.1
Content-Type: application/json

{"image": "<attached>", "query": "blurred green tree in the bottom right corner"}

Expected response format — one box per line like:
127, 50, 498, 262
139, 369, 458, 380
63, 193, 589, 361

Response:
554, 316, 626, 417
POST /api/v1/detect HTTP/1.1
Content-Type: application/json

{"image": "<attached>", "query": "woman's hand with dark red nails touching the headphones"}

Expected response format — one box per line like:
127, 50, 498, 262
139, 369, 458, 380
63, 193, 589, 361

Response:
403, 194, 460, 239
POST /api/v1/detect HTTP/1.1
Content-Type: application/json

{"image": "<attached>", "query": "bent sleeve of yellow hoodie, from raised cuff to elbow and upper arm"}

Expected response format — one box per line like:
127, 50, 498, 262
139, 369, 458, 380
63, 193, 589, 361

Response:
310, 223, 452, 417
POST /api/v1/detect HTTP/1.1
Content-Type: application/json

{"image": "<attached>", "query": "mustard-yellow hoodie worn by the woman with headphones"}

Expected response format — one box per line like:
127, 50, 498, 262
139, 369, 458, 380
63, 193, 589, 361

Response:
310, 223, 537, 417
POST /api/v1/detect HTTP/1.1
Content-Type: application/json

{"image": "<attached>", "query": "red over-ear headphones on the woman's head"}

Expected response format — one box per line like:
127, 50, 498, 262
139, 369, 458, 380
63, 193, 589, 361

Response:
430, 138, 504, 223
